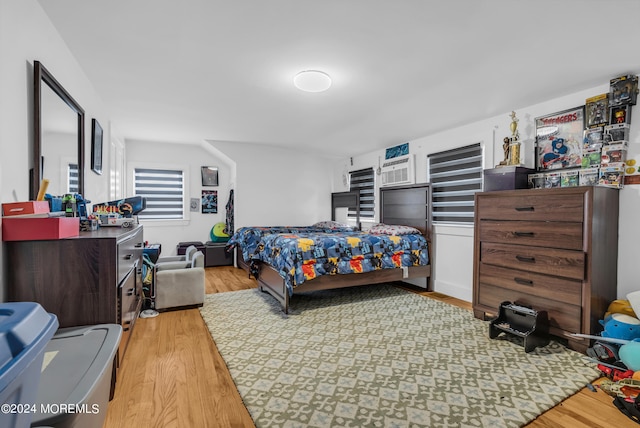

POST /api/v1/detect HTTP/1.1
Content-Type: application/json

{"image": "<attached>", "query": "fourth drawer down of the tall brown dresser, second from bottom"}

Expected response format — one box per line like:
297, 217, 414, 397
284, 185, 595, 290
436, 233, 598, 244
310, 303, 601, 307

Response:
479, 263, 582, 306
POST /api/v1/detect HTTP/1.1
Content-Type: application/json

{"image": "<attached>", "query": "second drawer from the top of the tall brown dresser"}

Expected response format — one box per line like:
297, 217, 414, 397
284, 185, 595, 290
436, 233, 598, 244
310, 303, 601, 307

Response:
479, 220, 583, 250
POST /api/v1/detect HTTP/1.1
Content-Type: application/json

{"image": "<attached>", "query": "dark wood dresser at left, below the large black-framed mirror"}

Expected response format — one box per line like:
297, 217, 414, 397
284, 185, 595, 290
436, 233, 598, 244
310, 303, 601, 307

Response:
6, 226, 144, 360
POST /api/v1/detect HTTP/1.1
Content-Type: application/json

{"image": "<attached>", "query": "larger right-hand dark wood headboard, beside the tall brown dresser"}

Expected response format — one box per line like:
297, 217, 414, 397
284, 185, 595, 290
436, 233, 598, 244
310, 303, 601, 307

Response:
380, 183, 431, 240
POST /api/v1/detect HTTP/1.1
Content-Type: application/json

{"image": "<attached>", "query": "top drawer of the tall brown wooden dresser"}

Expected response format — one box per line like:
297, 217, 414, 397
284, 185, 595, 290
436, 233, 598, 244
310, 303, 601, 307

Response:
476, 190, 584, 223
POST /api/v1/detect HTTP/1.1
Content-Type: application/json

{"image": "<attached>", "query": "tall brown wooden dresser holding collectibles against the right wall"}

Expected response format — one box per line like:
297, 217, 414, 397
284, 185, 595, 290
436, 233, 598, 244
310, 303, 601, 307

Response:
473, 187, 619, 351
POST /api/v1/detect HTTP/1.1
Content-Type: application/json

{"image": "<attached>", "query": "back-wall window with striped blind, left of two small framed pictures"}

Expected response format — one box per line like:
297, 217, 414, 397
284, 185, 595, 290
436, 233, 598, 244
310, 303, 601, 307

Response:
133, 168, 184, 220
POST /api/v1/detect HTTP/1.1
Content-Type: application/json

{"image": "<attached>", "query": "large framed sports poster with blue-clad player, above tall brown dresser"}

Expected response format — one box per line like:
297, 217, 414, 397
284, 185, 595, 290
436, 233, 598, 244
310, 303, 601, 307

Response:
535, 106, 585, 171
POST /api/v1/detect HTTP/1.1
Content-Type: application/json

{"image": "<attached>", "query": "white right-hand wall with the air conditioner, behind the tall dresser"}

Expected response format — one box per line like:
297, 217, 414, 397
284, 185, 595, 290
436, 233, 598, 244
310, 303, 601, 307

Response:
333, 85, 640, 301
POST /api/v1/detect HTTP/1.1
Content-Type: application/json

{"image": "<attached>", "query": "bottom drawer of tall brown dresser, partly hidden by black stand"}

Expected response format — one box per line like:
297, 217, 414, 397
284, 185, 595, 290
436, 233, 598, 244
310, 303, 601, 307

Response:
478, 285, 582, 333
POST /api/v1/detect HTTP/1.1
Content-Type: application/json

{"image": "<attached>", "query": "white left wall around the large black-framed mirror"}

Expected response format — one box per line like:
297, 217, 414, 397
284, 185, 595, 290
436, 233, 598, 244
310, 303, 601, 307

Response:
0, 0, 110, 301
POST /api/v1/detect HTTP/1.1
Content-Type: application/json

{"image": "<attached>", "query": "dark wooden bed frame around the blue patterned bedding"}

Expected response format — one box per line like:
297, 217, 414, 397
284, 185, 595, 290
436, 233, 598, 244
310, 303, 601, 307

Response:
244, 184, 433, 313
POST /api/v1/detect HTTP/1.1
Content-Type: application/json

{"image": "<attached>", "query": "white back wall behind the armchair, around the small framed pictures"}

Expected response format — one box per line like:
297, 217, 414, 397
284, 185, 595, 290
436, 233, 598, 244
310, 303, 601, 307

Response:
126, 140, 331, 255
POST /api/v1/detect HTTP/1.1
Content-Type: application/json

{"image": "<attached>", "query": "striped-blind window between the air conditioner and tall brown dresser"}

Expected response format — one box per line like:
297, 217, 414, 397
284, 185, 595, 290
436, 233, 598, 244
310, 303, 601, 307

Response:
427, 143, 483, 224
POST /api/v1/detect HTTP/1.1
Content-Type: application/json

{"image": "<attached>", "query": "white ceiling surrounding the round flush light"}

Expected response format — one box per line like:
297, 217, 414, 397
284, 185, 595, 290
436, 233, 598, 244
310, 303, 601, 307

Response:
39, 0, 640, 156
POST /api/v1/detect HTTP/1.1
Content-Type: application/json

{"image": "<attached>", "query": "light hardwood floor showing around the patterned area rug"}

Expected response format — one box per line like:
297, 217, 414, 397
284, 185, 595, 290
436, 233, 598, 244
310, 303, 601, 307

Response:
104, 267, 637, 428
